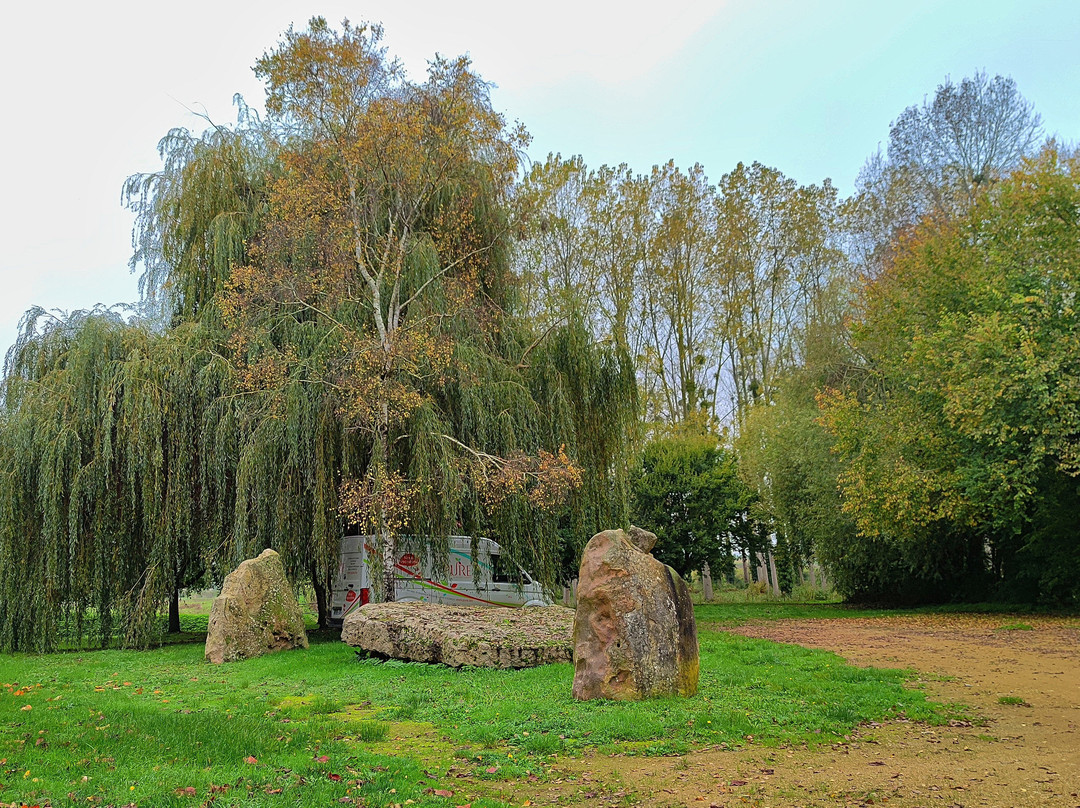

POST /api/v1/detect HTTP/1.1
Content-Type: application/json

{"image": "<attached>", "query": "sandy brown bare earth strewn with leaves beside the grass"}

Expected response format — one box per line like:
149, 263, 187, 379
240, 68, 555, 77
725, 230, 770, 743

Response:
501, 615, 1080, 808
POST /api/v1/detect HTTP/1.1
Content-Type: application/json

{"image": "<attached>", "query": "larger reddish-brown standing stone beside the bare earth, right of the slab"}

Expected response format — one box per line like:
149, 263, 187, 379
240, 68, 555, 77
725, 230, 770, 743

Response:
573, 527, 698, 700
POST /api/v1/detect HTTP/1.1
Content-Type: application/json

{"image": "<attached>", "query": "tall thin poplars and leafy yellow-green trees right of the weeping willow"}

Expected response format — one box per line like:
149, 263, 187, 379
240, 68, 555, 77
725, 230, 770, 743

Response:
509, 73, 1080, 605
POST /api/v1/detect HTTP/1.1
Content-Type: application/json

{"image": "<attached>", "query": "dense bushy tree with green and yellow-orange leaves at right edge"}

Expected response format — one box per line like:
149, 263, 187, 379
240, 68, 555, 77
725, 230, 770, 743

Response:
824, 147, 1080, 602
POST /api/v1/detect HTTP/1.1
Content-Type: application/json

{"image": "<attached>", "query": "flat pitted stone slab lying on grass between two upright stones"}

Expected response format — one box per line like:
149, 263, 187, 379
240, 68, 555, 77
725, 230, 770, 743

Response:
341, 603, 573, 668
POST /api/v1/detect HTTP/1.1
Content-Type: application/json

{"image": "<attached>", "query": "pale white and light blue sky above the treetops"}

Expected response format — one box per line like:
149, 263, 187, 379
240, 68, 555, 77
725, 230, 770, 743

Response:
0, 0, 1080, 351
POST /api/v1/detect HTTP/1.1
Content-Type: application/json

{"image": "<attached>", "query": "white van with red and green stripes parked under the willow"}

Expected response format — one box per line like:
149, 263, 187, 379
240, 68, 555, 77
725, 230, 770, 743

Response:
330, 536, 552, 625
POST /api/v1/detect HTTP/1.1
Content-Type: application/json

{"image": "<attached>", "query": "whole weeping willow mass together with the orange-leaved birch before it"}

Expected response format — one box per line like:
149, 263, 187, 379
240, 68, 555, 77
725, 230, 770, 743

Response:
0, 19, 636, 649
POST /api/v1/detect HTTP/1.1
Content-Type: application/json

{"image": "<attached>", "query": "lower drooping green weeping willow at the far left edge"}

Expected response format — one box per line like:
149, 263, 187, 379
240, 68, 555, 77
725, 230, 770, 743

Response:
0, 309, 234, 650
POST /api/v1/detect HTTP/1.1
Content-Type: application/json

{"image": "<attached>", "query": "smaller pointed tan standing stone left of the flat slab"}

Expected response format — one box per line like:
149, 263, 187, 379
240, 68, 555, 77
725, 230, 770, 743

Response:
206, 550, 308, 662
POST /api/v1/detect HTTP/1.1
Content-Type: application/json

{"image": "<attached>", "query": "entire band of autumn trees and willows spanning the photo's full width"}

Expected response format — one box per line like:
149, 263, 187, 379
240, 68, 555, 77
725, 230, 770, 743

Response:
0, 18, 1067, 649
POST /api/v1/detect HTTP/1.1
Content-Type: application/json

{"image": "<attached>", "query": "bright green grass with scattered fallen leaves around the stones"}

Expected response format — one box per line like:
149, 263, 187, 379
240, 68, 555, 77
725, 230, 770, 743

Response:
0, 605, 955, 808
